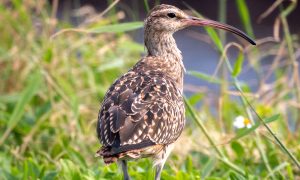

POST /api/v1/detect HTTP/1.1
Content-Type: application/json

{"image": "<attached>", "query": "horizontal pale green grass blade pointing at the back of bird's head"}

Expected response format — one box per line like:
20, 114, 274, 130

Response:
88, 21, 144, 33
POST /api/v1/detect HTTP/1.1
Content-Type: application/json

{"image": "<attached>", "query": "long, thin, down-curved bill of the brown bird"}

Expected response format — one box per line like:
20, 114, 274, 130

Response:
185, 16, 256, 45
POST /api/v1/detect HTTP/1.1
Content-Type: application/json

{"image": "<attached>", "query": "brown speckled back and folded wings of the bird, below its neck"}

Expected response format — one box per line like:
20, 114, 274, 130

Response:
97, 57, 185, 163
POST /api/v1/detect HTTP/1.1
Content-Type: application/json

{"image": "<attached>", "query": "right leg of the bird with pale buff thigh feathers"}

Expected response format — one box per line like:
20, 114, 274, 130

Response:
154, 144, 174, 180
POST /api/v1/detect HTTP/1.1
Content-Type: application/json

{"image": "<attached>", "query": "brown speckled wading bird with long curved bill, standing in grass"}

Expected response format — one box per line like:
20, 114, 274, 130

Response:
96, 4, 255, 180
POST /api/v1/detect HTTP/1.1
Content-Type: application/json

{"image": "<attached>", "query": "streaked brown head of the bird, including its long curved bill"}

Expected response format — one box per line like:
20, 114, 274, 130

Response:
145, 4, 255, 45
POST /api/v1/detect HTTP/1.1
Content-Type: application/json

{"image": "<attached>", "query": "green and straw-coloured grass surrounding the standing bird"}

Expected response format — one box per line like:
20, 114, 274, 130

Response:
0, 0, 300, 179
